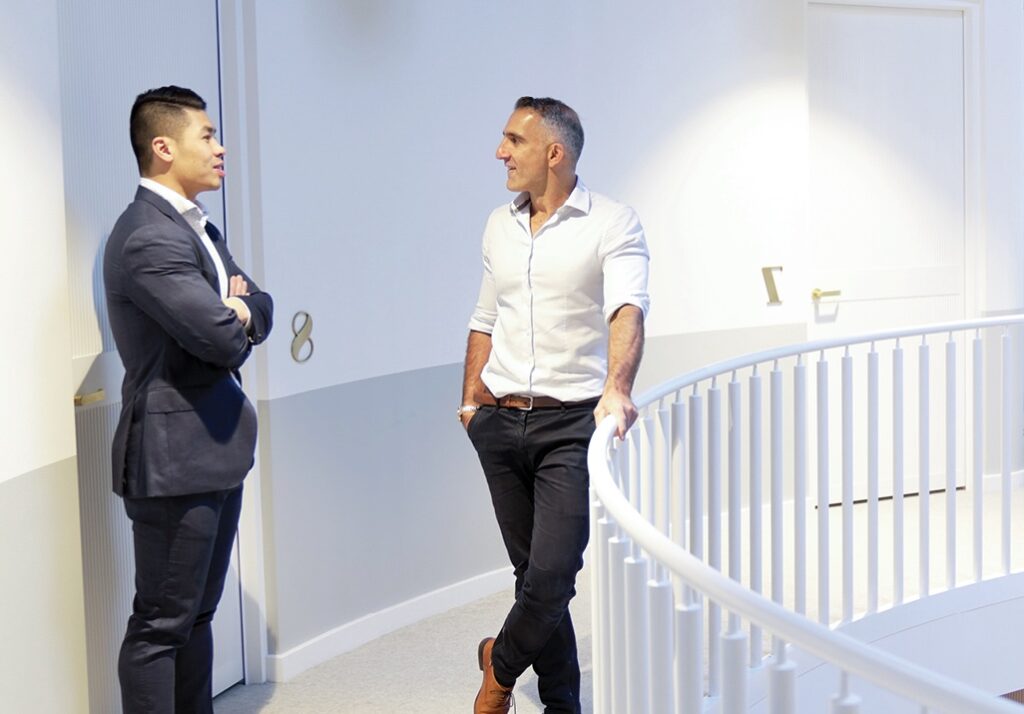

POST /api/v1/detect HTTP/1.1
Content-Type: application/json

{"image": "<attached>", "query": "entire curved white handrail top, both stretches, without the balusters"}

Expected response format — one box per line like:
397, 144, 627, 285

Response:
588, 314, 1024, 714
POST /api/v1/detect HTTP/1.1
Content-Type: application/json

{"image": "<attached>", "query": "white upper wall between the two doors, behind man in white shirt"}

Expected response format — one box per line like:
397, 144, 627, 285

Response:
247, 0, 806, 398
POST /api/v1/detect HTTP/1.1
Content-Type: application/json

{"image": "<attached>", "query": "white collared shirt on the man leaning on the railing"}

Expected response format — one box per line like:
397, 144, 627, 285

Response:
469, 179, 650, 402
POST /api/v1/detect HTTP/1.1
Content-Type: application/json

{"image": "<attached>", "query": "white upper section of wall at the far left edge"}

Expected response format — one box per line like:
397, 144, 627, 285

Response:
0, 0, 75, 481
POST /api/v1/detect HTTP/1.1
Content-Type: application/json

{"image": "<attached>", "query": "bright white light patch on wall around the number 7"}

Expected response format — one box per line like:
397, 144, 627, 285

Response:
628, 78, 807, 335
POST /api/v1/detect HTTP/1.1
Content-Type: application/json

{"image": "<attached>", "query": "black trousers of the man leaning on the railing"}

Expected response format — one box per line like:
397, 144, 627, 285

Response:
469, 401, 596, 713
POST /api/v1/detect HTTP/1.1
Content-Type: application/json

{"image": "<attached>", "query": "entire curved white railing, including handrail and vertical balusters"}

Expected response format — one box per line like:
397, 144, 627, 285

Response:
588, 314, 1024, 714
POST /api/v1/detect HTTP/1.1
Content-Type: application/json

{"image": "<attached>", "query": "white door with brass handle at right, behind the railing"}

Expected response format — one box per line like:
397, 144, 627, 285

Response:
802, 0, 977, 502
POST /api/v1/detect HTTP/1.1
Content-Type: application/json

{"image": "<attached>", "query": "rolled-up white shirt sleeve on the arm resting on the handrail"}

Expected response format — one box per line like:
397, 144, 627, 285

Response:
600, 206, 650, 322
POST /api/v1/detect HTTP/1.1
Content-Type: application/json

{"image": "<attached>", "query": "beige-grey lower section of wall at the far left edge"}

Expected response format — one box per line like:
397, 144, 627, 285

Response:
0, 458, 89, 714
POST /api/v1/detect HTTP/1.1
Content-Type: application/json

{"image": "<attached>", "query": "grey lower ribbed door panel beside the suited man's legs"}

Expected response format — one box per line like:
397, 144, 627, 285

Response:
76, 403, 134, 712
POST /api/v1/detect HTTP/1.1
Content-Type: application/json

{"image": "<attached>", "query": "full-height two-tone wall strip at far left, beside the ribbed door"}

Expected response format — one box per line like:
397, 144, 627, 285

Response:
0, 0, 88, 712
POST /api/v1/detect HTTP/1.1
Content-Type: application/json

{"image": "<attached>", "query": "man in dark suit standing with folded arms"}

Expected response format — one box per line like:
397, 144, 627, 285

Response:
103, 86, 273, 714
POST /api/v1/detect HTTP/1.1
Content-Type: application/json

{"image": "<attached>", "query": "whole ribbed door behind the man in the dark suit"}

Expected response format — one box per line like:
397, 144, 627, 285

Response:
58, 0, 243, 712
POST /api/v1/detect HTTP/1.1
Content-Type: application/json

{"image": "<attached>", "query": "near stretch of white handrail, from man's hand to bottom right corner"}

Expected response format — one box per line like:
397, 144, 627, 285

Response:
588, 416, 1021, 714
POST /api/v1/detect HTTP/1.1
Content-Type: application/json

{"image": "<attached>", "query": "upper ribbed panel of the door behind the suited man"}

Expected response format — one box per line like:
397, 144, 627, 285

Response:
57, 0, 223, 358
